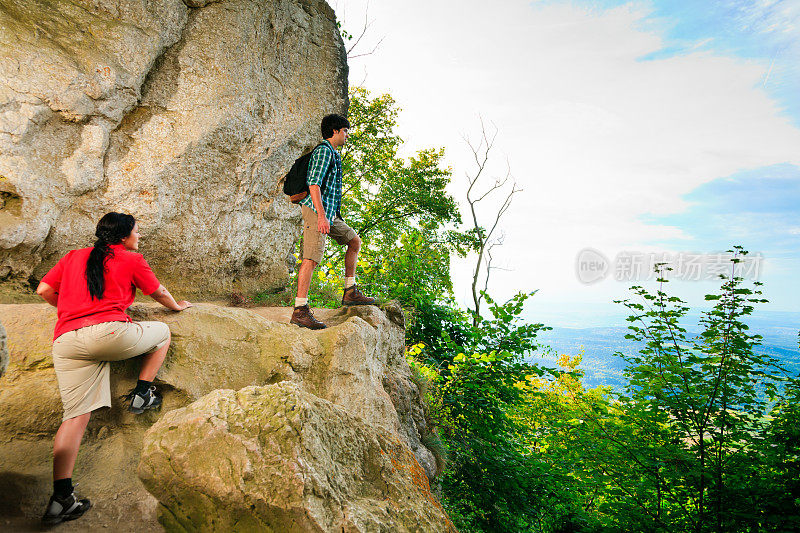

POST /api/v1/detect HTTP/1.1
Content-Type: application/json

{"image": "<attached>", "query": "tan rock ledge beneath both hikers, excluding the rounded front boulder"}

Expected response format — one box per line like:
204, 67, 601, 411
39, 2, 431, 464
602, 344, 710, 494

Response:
0, 304, 444, 532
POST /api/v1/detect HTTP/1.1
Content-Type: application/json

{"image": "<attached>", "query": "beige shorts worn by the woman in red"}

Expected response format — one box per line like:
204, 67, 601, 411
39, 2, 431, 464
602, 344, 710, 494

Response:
53, 322, 169, 420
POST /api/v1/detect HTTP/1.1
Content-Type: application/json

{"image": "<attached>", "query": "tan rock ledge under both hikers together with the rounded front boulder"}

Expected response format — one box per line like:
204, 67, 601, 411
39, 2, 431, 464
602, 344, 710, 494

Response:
0, 304, 452, 532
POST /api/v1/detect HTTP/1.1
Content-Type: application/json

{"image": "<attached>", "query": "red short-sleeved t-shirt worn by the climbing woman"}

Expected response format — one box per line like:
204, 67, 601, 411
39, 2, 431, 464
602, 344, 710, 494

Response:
42, 244, 161, 340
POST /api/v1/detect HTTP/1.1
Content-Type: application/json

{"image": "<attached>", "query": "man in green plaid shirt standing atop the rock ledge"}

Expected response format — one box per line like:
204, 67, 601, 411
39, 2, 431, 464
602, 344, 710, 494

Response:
290, 115, 376, 329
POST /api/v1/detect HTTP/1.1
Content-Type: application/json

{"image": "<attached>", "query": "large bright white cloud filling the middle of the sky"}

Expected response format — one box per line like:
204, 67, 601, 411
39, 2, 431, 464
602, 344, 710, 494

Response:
337, 0, 800, 308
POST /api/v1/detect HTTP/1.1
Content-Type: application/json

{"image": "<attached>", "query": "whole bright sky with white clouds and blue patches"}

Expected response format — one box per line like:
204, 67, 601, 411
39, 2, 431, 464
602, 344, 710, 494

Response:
331, 0, 800, 328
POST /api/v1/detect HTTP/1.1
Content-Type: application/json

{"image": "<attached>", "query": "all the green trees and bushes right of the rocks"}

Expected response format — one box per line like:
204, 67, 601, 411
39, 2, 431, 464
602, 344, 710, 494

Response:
294, 88, 800, 533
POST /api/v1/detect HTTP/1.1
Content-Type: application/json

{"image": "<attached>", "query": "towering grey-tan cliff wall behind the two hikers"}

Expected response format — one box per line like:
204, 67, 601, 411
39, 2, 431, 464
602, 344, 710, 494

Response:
0, 0, 347, 295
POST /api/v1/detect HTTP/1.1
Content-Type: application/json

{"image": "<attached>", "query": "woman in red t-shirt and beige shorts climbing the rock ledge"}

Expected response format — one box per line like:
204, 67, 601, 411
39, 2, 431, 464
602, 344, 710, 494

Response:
36, 213, 192, 525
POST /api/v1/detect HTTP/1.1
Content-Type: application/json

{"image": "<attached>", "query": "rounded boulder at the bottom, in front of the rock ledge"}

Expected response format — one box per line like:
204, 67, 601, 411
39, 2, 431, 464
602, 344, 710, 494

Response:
139, 382, 453, 532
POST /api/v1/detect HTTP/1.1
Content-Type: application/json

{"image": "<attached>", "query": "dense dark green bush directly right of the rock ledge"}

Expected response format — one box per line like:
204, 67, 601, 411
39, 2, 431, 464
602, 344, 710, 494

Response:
410, 293, 583, 531
